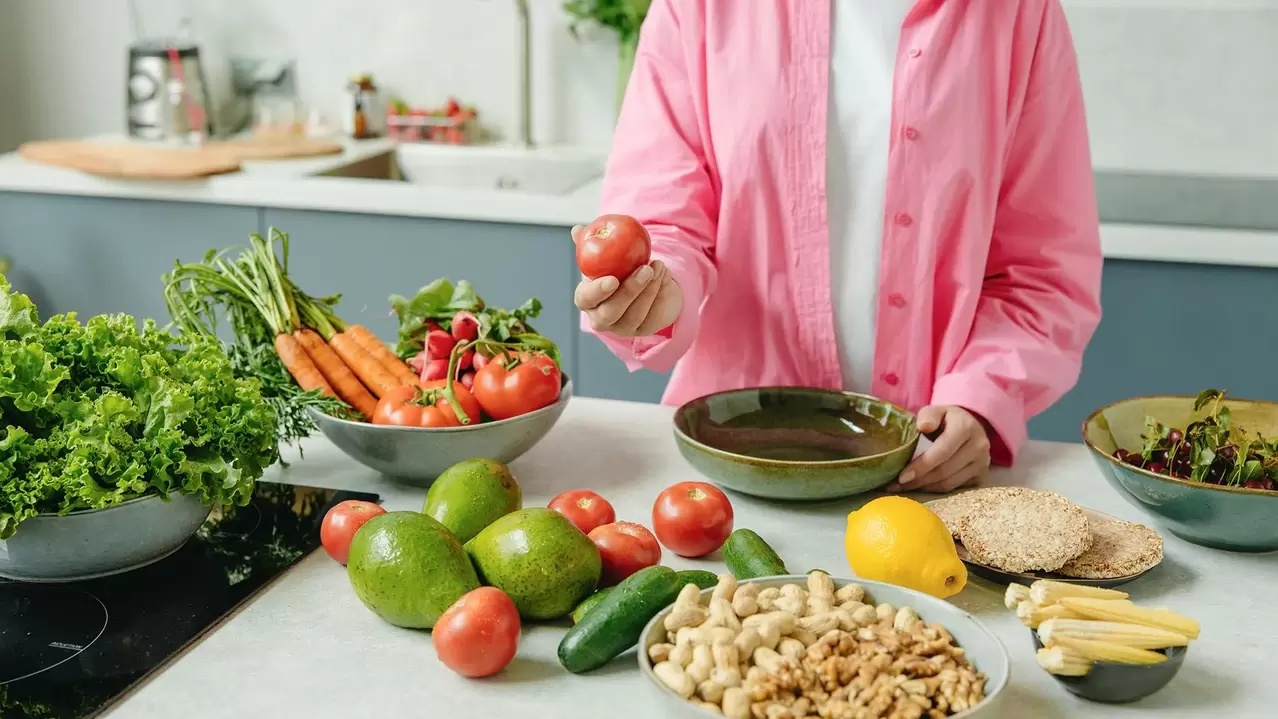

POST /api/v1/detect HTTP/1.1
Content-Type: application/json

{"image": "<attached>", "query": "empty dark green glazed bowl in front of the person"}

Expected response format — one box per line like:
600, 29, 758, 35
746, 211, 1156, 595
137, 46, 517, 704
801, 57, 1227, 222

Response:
675, 387, 919, 499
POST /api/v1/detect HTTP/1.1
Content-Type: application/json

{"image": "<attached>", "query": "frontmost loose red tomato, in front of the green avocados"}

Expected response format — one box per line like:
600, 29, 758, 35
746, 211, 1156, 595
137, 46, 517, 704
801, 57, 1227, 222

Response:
431, 586, 519, 679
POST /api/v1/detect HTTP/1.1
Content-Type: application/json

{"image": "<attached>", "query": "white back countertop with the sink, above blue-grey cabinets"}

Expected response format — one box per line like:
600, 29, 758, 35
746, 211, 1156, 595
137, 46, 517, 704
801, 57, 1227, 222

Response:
0, 139, 1278, 267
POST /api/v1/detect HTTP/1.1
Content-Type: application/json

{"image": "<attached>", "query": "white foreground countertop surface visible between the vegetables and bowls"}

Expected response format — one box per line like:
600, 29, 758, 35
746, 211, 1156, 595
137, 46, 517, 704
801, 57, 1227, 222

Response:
109, 398, 1278, 719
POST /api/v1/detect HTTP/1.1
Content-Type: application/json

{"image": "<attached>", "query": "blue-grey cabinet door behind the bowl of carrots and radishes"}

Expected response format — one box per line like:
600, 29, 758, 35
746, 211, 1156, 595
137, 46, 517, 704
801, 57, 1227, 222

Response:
263, 209, 576, 378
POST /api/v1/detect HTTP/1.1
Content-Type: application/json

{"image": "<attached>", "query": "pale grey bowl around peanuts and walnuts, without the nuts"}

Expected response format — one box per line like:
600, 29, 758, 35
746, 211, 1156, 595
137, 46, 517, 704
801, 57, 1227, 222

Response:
639, 575, 1011, 719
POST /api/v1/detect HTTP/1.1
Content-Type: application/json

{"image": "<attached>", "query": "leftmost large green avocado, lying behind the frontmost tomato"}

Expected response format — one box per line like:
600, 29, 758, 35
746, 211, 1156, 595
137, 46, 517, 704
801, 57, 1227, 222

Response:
346, 512, 479, 630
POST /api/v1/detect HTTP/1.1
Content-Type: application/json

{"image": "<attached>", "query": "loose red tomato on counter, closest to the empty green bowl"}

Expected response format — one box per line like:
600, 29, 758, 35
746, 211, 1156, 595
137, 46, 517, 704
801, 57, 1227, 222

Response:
652, 481, 732, 557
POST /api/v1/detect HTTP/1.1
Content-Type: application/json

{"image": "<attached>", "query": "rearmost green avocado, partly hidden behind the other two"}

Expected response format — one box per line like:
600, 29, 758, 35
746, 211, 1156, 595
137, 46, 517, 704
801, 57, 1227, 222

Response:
422, 460, 524, 543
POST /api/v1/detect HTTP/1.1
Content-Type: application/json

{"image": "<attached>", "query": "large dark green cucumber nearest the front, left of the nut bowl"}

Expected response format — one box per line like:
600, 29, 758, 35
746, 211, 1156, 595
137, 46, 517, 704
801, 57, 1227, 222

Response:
558, 564, 684, 674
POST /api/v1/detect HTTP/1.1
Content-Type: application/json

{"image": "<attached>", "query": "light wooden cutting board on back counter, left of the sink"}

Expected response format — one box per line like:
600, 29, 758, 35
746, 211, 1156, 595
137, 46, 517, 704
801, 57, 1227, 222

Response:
18, 138, 343, 180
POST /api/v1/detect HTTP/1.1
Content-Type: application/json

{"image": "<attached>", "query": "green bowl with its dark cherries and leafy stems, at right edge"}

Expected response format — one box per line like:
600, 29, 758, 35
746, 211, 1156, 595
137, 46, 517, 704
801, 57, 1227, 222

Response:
1082, 390, 1278, 552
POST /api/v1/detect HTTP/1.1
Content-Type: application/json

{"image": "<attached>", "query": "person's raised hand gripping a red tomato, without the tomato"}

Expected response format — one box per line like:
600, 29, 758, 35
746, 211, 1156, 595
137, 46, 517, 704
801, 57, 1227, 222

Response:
573, 225, 684, 337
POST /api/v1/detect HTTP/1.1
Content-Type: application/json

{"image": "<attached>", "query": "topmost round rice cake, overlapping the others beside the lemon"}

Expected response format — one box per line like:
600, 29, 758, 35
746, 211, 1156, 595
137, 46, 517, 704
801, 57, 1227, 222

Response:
959, 489, 1091, 572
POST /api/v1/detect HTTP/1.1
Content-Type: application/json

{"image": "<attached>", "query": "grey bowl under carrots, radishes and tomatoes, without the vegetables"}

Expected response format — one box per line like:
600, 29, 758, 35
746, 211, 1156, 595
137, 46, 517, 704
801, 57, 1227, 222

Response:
311, 375, 573, 487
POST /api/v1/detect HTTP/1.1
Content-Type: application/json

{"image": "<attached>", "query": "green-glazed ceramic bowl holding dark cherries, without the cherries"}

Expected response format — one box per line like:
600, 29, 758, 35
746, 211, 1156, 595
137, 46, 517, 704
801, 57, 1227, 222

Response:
1082, 396, 1278, 552
